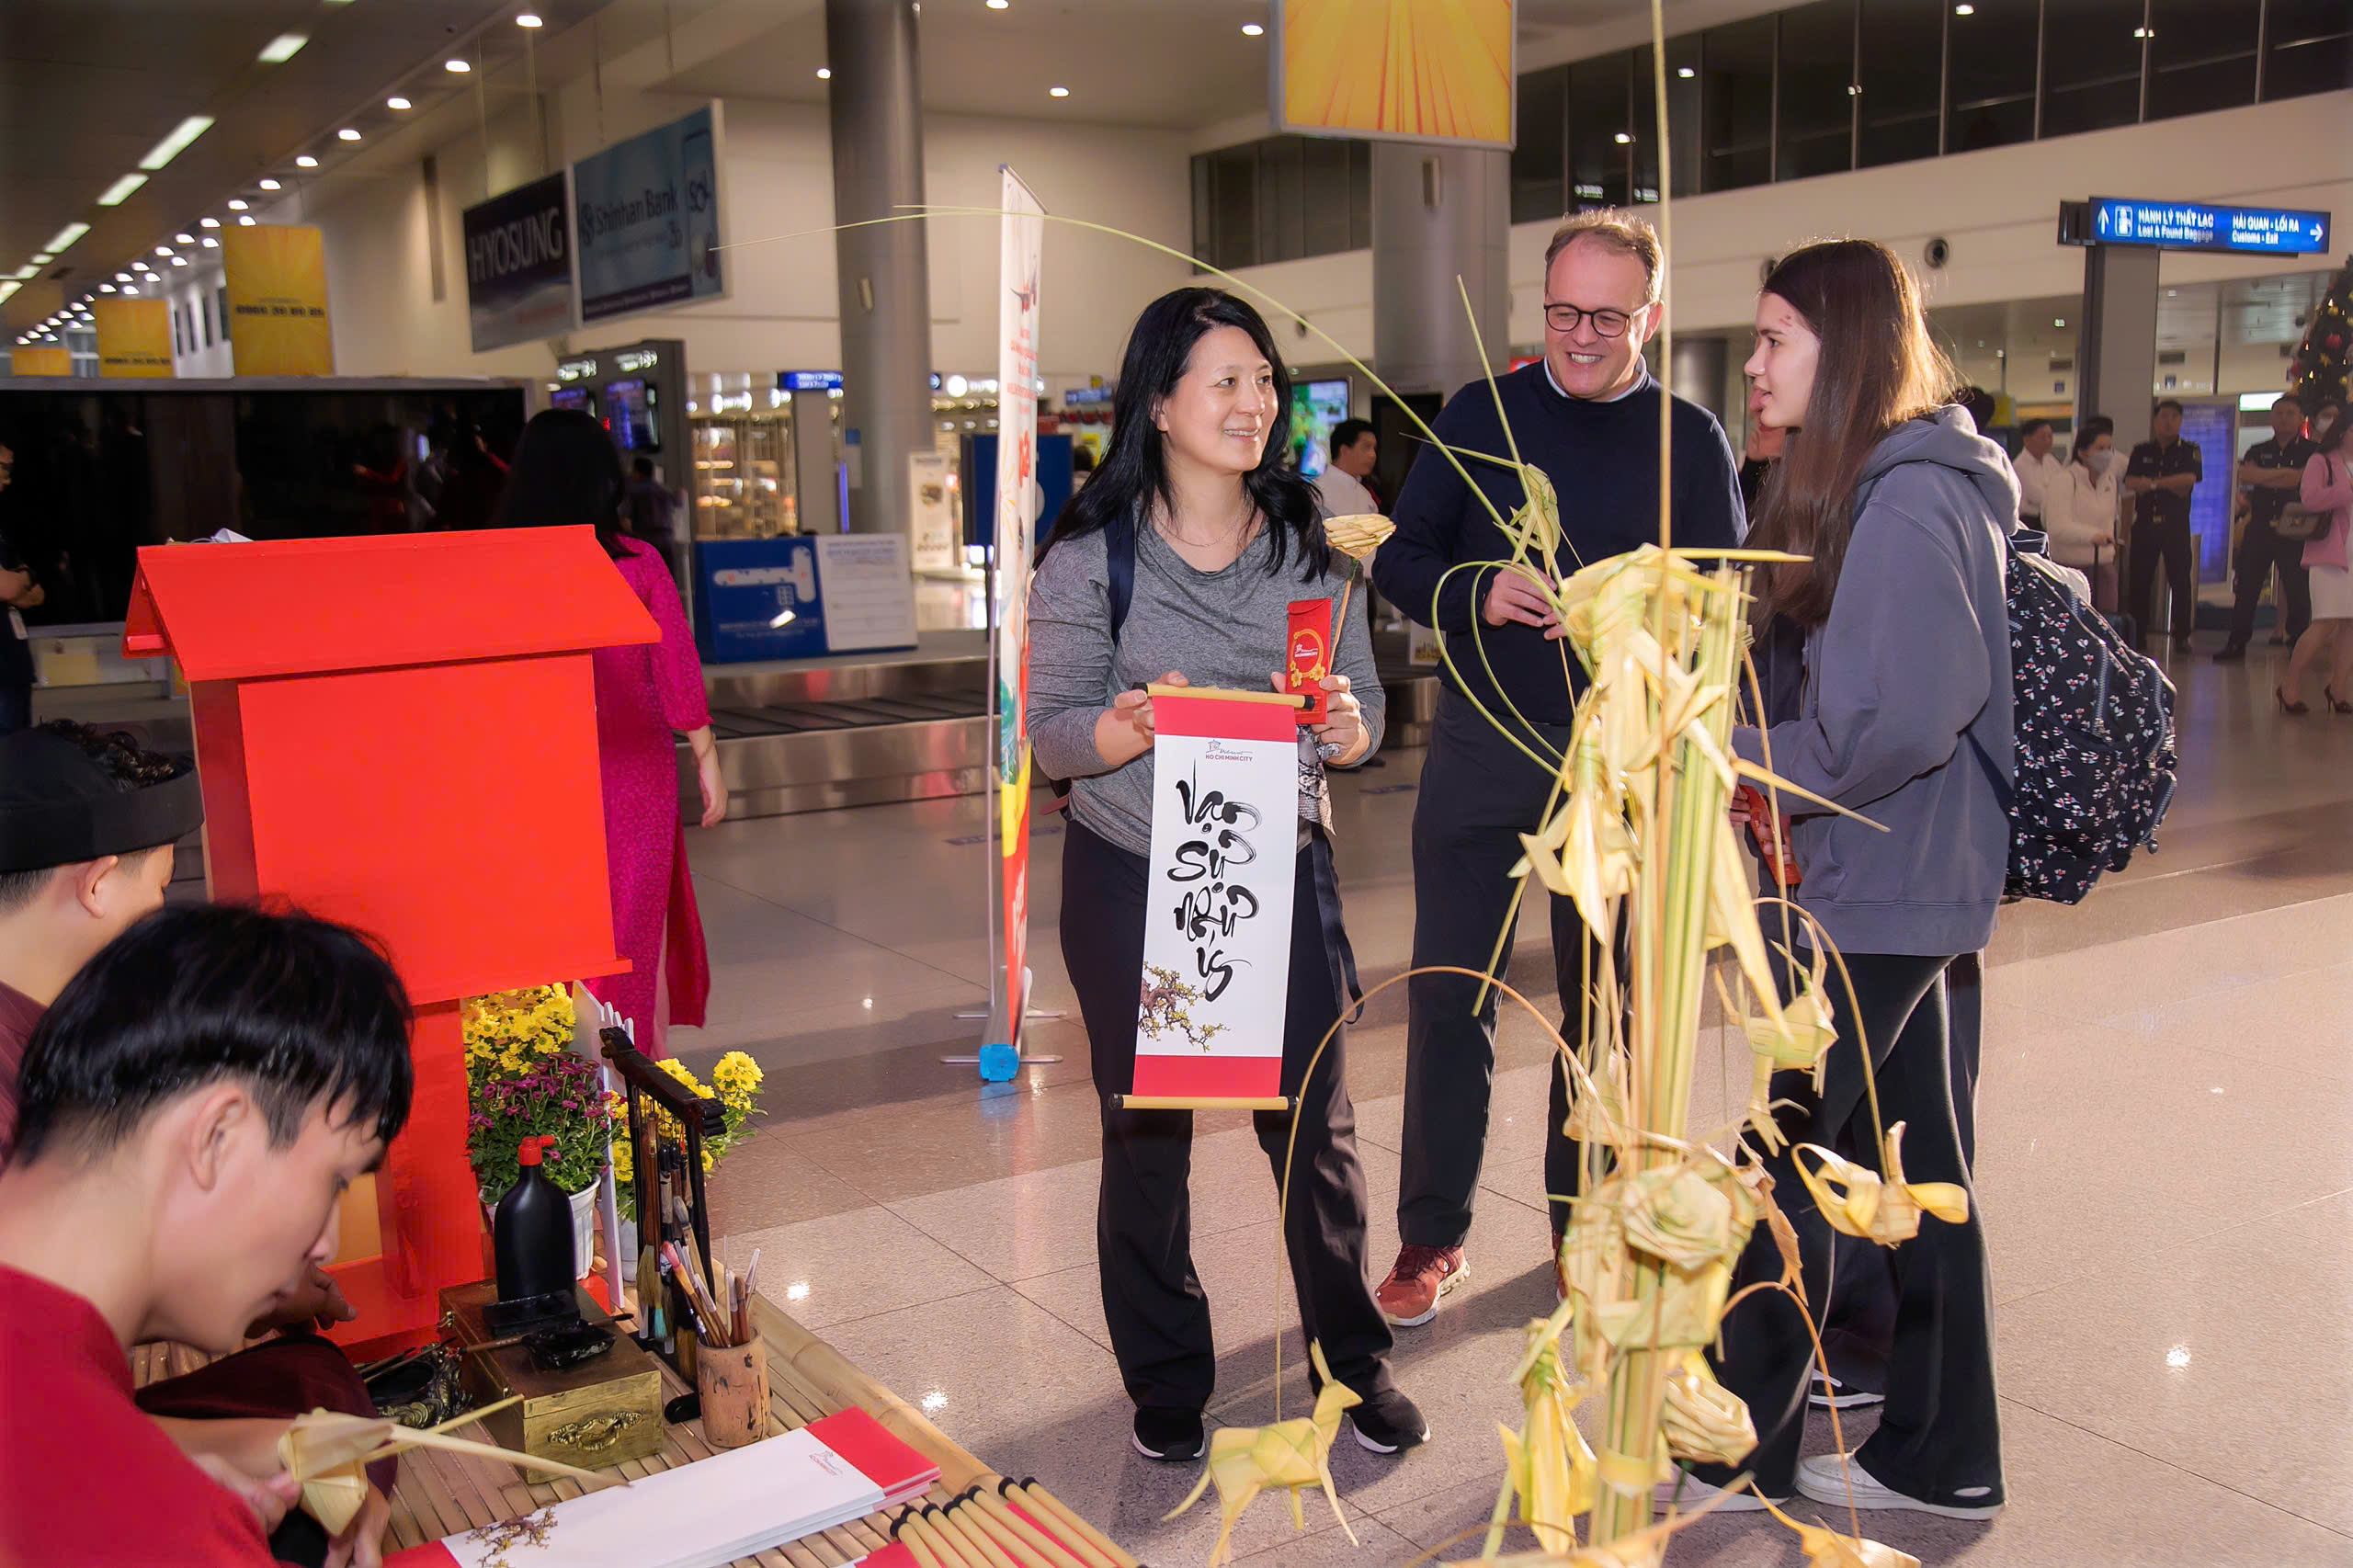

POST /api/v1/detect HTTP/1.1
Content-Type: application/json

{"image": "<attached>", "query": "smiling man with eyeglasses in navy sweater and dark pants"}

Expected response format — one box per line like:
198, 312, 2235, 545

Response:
1371, 210, 1741, 1325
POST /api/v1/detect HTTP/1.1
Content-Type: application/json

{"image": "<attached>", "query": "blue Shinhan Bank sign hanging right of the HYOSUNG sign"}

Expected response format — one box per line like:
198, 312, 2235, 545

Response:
572, 104, 727, 324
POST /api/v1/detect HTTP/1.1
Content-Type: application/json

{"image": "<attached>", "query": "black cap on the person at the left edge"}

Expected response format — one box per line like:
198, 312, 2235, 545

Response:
0, 725, 205, 873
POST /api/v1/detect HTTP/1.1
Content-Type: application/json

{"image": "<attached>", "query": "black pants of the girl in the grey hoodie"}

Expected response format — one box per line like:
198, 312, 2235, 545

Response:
1694, 953, 2003, 1505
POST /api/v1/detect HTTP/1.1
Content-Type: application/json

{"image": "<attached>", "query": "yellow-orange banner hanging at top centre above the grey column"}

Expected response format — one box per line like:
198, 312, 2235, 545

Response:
1276, 0, 1513, 146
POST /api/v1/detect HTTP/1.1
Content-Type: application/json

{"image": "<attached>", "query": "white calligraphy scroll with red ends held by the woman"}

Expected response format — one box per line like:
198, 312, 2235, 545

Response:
1134, 685, 1299, 1102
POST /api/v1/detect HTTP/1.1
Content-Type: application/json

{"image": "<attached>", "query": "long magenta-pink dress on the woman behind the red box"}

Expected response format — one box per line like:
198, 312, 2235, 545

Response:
588, 540, 710, 1057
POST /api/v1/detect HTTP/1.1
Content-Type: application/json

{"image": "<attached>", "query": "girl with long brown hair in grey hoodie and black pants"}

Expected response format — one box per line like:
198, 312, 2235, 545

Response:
1682, 240, 2018, 1518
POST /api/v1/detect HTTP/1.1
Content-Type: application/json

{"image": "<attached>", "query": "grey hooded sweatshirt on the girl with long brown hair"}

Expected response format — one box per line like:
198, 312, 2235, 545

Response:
1732, 407, 2018, 956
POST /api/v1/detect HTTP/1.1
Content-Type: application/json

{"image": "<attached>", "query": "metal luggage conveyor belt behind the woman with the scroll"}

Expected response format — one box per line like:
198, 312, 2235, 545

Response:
677, 657, 1438, 822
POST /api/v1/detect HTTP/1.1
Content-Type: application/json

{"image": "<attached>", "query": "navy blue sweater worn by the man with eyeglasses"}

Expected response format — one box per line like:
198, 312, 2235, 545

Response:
1371, 360, 1741, 725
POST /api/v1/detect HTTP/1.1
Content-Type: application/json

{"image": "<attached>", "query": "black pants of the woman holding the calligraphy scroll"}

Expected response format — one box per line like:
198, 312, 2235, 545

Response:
1062, 822, 1391, 1410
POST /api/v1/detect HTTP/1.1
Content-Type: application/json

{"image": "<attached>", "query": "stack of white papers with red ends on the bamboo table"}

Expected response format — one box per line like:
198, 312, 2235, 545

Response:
393, 1410, 938, 1568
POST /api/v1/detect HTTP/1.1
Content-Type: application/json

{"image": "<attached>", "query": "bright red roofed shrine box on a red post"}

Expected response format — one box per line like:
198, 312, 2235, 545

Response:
122, 528, 661, 1351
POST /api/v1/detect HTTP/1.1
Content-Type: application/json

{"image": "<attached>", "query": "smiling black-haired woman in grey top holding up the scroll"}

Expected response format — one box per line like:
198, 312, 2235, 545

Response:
1029, 288, 1428, 1460
